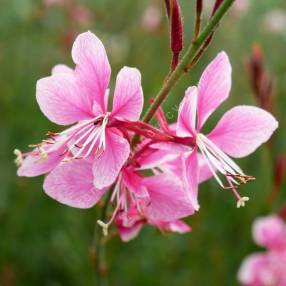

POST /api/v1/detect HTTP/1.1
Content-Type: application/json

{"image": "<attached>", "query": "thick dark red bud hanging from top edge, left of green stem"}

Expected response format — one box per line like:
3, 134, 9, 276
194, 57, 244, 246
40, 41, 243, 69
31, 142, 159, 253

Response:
165, 0, 183, 70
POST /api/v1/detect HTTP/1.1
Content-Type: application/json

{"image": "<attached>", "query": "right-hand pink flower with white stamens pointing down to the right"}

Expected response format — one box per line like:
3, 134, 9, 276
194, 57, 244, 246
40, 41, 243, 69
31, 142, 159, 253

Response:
159, 52, 278, 207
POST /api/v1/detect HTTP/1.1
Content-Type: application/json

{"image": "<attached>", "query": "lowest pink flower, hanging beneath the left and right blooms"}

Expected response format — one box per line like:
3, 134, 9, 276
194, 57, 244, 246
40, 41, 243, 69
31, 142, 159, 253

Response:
44, 158, 194, 236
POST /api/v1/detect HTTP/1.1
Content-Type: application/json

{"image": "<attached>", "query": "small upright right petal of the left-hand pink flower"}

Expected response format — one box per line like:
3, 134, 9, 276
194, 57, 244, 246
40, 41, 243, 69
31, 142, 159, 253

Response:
112, 67, 143, 121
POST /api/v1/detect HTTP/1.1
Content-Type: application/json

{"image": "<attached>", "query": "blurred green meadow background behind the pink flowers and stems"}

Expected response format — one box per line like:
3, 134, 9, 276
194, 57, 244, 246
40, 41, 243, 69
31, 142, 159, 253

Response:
0, 0, 286, 286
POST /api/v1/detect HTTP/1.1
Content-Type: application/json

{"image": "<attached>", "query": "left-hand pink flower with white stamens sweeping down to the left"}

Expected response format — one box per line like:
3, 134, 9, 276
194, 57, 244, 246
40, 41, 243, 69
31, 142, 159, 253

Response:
18, 32, 143, 189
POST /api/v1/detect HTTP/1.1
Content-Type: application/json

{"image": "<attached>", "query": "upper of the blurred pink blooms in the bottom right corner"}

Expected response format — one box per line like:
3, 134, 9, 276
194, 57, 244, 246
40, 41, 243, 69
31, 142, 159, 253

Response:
253, 215, 286, 250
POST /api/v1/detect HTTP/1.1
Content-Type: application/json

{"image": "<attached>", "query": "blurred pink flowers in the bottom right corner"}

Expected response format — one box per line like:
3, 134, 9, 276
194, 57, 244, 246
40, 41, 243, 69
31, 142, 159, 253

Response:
238, 215, 286, 286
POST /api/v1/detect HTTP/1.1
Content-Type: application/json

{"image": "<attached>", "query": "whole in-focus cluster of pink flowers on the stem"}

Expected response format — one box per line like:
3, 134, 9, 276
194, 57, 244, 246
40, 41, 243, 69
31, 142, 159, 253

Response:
15, 32, 278, 241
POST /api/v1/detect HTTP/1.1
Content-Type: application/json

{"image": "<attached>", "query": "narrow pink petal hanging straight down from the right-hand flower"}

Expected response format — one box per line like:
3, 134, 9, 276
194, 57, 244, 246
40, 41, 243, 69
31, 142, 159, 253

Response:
182, 150, 200, 211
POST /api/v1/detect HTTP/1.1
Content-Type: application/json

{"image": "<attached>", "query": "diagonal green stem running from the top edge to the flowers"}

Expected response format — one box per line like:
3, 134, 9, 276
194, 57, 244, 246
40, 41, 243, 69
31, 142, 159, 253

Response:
143, 0, 234, 122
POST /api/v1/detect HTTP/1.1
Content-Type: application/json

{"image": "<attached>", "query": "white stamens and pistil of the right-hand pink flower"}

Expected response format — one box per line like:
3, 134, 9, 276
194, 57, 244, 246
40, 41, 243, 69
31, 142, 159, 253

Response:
196, 133, 255, 208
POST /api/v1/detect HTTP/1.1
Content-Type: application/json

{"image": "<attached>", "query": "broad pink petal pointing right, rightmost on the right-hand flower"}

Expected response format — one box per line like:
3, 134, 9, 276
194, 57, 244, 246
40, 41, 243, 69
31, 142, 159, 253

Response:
208, 106, 278, 158
